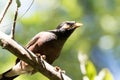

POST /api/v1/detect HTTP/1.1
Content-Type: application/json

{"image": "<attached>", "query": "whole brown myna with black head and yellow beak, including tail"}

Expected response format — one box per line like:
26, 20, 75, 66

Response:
0, 21, 82, 80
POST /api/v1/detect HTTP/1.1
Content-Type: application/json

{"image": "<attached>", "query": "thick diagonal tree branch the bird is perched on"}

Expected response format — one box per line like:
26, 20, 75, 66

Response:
0, 32, 72, 80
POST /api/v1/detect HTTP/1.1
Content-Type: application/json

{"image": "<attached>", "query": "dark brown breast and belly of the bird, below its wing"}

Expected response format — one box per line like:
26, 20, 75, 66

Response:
36, 39, 63, 63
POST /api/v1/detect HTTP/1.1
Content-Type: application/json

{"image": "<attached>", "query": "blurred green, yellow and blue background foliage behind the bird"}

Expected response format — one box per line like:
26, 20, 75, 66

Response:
0, 0, 120, 80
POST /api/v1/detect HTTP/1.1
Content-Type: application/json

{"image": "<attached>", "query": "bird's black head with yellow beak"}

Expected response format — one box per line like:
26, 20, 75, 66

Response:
56, 21, 83, 38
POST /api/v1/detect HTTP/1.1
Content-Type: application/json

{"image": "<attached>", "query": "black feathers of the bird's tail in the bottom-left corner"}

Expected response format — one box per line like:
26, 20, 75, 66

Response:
0, 69, 18, 80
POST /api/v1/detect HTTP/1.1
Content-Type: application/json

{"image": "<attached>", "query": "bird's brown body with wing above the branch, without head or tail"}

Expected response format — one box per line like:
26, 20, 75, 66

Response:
26, 31, 64, 64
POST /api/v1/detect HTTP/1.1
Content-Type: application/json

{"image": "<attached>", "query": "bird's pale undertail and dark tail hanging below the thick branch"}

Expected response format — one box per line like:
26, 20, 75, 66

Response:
0, 61, 33, 80
